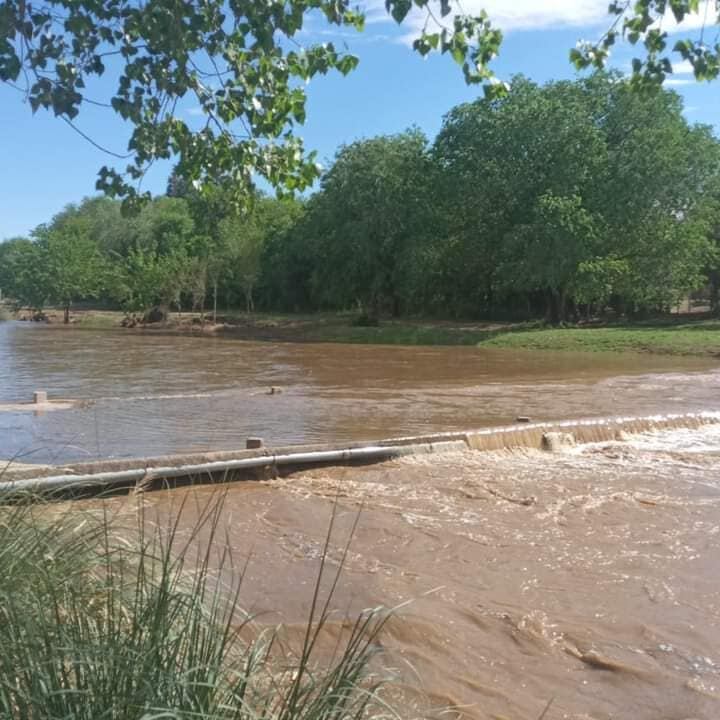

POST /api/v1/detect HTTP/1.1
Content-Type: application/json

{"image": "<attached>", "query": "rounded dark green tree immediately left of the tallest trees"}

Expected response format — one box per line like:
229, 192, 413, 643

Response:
308, 130, 431, 318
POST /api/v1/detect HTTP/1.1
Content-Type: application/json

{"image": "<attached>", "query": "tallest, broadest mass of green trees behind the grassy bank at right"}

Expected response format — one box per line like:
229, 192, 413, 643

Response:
433, 74, 720, 322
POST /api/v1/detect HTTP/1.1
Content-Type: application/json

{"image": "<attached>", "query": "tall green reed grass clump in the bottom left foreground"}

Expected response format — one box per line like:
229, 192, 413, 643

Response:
0, 490, 391, 720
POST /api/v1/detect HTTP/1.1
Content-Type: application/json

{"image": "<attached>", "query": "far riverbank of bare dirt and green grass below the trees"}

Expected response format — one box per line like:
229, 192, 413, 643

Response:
9, 310, 720, 356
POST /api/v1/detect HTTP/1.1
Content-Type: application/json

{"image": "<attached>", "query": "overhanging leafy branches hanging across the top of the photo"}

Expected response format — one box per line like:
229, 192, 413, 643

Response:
0, 0, 720, 204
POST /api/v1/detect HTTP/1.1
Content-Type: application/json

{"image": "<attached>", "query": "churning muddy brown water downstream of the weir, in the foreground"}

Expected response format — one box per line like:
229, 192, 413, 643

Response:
77, 424, 720, 720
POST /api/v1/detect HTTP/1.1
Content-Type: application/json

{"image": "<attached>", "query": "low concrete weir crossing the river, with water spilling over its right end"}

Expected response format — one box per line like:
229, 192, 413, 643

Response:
0, 412, 720, 495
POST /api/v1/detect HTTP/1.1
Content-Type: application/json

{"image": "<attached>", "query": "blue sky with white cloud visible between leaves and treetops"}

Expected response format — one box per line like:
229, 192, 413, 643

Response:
0, 0, 720, 239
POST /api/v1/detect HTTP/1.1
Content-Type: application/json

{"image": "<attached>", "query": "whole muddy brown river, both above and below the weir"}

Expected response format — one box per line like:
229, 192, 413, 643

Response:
0, 323, 720, 720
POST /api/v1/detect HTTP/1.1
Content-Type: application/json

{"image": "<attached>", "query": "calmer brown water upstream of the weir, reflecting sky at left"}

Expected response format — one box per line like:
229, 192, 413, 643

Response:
0, 322, 720, 462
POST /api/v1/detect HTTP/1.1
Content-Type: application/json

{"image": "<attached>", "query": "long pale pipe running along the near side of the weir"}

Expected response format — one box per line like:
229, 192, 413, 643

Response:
0, 442, 467, 494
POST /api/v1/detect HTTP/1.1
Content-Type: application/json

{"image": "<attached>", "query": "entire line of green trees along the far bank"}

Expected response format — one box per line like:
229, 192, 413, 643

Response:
0, 74, 720, 322
